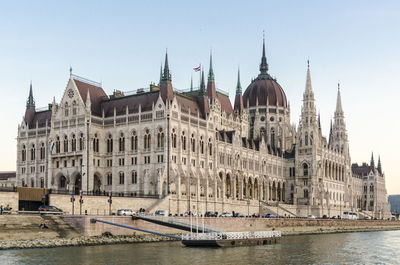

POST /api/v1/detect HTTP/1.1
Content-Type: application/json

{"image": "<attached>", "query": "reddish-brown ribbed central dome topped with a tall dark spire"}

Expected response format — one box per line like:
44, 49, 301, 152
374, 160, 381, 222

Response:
243, 42, 287, 108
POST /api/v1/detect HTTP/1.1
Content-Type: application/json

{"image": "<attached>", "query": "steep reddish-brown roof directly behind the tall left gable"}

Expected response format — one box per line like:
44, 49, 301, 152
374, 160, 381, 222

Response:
74, 78, 108, 116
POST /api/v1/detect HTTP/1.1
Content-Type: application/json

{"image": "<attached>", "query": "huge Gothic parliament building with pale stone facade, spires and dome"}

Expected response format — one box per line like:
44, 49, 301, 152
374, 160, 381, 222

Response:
17, 41, 387, 218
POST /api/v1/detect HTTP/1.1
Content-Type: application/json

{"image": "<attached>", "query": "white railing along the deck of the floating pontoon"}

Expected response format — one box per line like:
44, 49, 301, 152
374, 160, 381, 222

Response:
182, 231, 282, 240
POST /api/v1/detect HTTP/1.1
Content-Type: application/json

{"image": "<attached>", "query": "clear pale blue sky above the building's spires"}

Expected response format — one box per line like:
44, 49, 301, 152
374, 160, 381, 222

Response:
0, 0, 400, 194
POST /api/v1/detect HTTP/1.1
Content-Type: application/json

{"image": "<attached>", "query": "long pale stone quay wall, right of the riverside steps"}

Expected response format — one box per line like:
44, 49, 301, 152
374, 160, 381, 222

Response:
64, 216, 400, 236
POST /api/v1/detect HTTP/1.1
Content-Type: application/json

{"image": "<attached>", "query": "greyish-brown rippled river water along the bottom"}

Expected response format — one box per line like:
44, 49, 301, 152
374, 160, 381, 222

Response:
0, 231, 400, 265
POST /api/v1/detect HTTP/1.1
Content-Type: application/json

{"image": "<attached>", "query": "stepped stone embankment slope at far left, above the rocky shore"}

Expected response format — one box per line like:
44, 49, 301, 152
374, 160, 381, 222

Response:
0, 215, 80, 240
